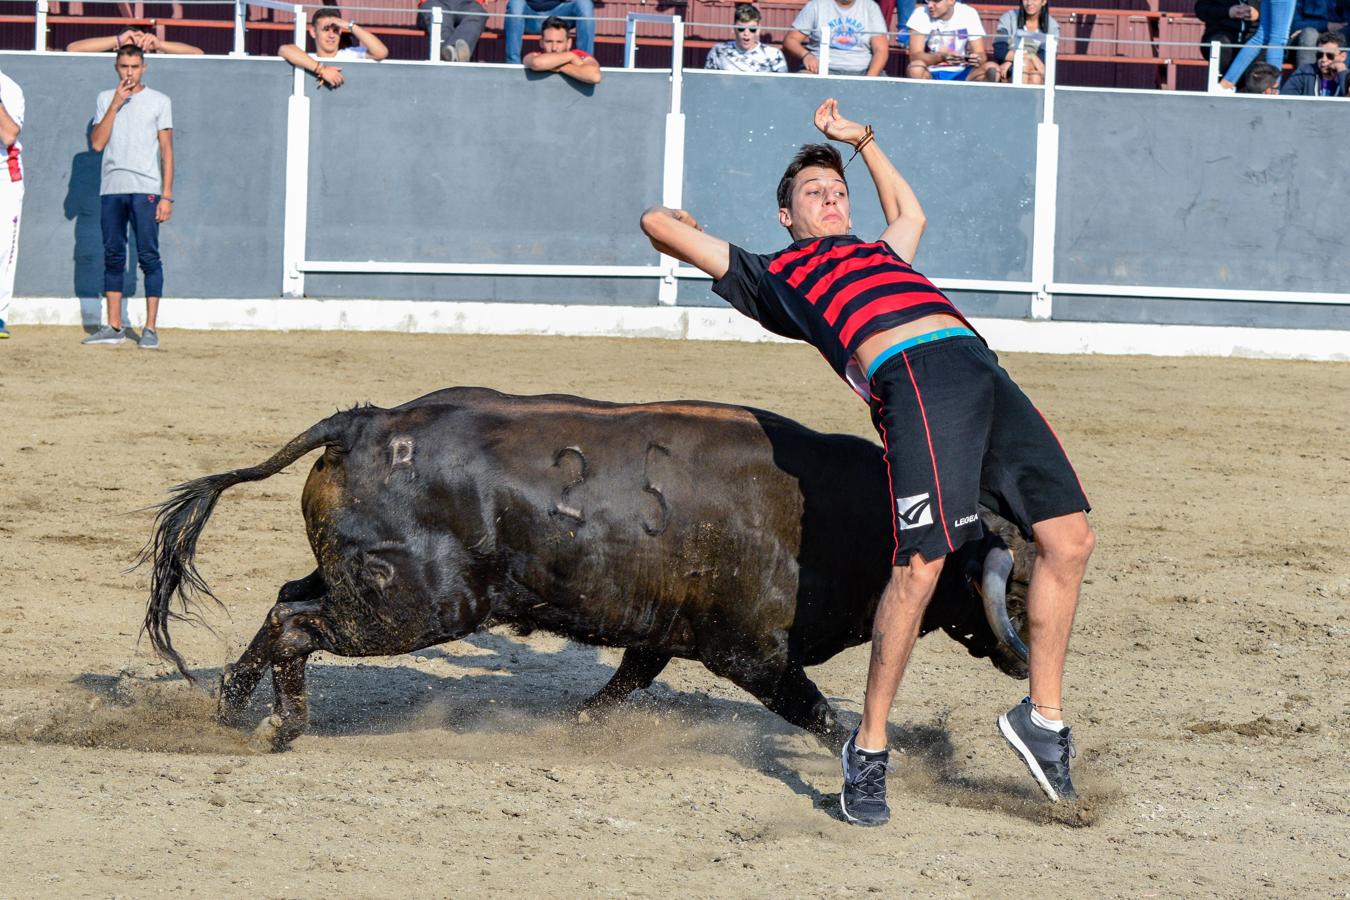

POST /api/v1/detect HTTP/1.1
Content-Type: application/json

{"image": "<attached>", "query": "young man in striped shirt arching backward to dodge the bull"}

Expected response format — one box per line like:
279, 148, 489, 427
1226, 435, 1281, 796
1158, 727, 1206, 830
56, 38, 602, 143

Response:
641, 100, 1094, 824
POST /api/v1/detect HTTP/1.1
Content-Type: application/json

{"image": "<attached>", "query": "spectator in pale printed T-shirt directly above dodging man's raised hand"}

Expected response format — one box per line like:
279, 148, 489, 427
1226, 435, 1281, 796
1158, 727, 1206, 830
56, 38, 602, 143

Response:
783, 0, 891, 76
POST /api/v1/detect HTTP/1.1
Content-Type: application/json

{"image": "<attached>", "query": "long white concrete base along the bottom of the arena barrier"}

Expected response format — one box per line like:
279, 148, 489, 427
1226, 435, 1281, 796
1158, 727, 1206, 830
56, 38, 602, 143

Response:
9, 298, 1350, 362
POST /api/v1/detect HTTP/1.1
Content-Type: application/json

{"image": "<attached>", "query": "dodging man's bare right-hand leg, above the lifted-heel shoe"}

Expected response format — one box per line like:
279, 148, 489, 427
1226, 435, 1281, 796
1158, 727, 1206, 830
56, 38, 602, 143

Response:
1026, 513, 1096, 719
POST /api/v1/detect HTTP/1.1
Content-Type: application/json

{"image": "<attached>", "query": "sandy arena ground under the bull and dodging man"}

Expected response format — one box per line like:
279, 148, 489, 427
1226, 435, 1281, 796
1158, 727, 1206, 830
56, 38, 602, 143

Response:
0, 328, 1350, 897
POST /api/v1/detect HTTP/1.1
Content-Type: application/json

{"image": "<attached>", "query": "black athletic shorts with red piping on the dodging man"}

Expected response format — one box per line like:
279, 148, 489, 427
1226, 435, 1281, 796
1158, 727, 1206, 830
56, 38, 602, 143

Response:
871, 337, 1089, 565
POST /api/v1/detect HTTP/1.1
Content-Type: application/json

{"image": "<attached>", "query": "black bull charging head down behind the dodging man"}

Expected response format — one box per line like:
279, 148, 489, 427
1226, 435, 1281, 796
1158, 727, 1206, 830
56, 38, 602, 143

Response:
142, 387, 1030, 748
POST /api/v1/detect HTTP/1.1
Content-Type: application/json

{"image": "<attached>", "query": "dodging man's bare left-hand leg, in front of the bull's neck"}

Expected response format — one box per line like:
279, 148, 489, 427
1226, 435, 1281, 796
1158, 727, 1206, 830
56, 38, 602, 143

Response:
857, 553, 946, 750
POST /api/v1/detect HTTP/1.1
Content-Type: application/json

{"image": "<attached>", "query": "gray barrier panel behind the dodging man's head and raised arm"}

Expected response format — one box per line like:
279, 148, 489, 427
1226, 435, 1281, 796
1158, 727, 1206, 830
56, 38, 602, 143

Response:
682, 72, 1041, 309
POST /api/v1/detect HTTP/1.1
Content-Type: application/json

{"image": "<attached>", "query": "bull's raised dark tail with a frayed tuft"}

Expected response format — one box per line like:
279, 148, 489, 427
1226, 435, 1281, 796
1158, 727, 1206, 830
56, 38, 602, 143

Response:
136, 410, 358, 684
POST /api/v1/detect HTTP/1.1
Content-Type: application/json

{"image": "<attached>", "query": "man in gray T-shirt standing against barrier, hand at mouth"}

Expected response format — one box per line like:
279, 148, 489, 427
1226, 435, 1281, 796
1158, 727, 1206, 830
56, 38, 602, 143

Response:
84, 45, 173, 349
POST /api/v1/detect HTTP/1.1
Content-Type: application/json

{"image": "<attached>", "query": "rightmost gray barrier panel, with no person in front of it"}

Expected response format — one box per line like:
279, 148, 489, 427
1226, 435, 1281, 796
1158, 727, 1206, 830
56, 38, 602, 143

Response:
1054, 90, 1350, 293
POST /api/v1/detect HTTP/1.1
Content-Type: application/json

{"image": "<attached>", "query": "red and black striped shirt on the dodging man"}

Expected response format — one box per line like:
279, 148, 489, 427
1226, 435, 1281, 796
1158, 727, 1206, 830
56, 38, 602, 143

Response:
713, 235, 973, 381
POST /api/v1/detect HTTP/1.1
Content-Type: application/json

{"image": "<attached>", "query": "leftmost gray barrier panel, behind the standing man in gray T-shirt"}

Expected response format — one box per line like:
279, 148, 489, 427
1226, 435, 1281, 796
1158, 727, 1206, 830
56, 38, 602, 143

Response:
0, 53, 290, 302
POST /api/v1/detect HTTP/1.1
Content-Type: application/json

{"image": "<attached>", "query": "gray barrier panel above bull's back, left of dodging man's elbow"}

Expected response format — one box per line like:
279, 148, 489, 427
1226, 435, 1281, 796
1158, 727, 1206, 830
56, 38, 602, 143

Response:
305, 65, 670, 305
